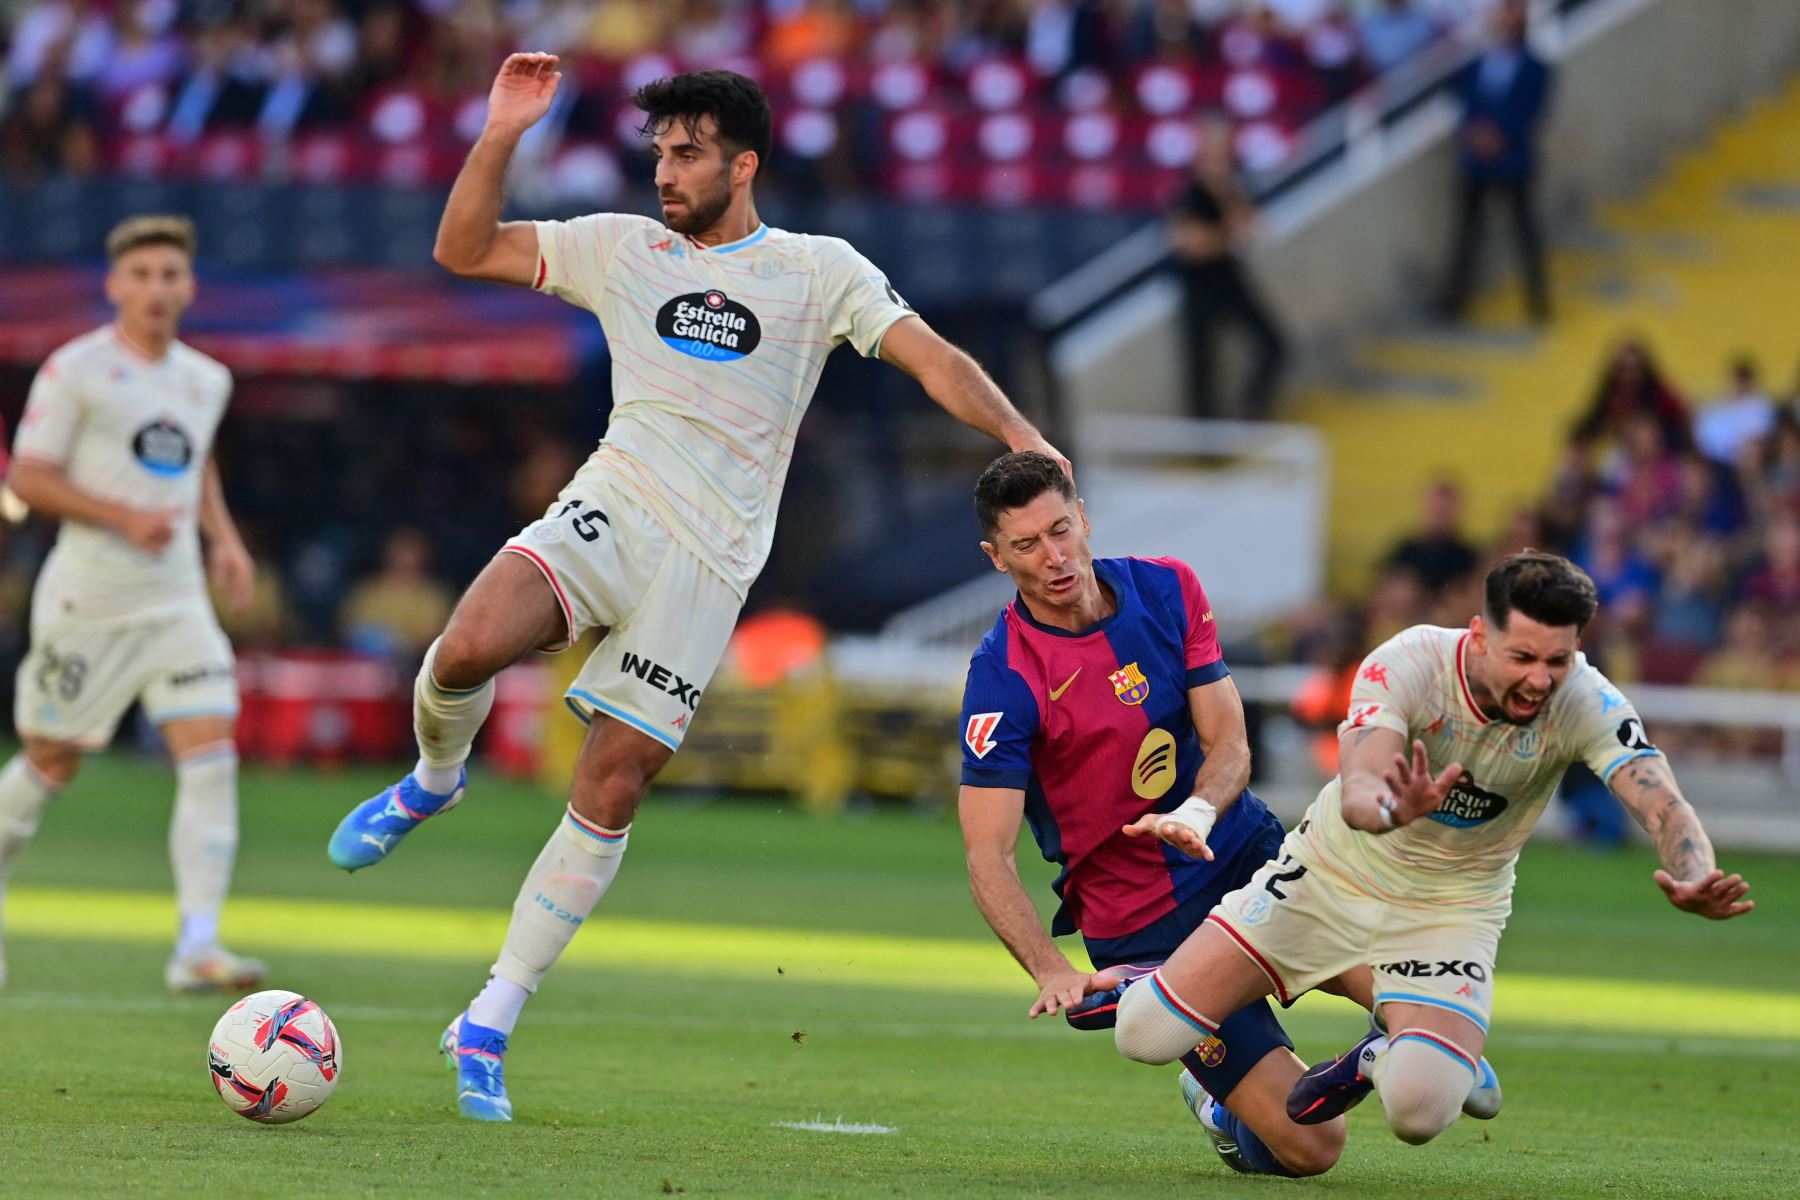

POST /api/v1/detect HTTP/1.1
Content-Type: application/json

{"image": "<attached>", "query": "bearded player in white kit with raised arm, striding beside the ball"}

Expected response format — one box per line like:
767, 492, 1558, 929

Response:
329, 54, 1064, 1121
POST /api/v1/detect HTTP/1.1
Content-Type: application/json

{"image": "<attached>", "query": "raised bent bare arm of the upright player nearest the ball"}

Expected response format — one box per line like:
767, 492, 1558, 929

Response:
432, 54, 562, 288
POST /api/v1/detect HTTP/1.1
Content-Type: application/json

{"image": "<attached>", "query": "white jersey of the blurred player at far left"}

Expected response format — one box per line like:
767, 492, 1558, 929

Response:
13, 326, 230, 624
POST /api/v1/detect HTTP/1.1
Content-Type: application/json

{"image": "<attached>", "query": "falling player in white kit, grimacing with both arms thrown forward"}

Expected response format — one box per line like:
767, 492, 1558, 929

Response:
1116, 551, 1753, 1144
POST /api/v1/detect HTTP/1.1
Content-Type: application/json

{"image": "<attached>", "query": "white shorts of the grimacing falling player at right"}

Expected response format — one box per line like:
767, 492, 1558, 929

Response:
1206, 831, 1507, 1033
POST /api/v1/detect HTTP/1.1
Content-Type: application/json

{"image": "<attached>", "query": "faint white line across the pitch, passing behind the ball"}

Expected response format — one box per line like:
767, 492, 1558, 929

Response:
0, 990, 1800, 1058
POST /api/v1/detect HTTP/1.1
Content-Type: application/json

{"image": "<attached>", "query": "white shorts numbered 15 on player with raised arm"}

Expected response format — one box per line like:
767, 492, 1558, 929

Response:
500, 477, 743, 750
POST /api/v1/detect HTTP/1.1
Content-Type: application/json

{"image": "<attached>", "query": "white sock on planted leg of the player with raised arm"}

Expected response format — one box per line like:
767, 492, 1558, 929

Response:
486, 810, 633, 1021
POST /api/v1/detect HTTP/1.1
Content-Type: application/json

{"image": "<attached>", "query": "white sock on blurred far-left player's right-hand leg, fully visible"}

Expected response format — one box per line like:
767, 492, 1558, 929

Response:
169, 741, 238, 959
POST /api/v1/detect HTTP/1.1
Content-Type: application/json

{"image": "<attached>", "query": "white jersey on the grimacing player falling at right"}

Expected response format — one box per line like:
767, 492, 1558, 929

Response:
1303, 624, 1660, 916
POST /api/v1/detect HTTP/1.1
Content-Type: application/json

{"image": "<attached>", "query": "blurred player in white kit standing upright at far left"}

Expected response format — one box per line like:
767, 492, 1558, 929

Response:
0, 216, 265, 991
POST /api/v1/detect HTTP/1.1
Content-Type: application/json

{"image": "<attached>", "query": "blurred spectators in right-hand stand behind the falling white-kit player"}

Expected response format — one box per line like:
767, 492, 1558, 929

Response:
1291, 338, 1800, 784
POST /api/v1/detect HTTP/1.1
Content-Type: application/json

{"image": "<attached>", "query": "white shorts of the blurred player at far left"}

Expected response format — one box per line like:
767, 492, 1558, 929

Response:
13, 611, 238, 750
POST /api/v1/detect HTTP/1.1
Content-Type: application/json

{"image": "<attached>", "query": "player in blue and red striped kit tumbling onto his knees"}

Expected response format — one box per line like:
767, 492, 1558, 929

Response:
959, 452, 1368, 1175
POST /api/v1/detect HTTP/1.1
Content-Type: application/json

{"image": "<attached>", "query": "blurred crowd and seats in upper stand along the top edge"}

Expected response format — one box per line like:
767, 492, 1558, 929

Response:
0, 0, 1492, 203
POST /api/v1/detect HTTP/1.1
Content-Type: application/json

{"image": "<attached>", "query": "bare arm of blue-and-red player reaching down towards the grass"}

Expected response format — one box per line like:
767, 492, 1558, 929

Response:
956, 784, 1114, 1020
